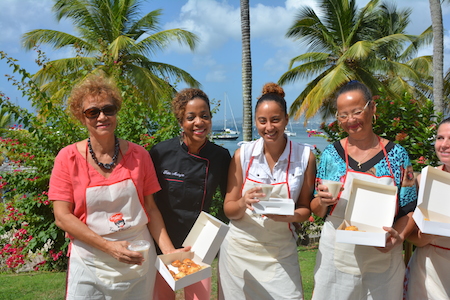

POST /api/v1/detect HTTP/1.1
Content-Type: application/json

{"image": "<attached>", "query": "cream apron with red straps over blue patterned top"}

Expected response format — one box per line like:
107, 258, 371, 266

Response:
313, 142, 405, 300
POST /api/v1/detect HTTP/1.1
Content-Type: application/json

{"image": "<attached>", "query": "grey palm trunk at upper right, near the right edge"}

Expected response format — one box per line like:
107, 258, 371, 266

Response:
430, 0, 444, 113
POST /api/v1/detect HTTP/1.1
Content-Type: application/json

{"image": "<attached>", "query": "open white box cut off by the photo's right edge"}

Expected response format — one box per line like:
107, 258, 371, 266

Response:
413, 166, 450, 237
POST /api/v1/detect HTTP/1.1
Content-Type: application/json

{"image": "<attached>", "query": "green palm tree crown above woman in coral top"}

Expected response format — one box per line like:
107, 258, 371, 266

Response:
22, 0, 200, 104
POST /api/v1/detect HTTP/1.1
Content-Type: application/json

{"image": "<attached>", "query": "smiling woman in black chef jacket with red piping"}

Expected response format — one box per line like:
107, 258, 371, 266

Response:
150, 88, 231, 300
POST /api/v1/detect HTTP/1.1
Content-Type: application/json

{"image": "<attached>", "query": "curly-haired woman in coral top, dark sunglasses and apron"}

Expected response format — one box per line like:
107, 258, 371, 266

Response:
49, 75, 185, 299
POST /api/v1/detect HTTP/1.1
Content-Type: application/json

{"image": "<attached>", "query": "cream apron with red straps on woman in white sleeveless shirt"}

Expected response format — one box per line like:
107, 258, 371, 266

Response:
219, 143, 303, 300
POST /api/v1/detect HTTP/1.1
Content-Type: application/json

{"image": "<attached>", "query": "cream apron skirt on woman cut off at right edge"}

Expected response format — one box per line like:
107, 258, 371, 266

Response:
404, 224, 450, 300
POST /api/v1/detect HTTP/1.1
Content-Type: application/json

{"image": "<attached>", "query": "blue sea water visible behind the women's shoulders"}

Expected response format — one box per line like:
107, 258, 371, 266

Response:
214, 127, 329, 156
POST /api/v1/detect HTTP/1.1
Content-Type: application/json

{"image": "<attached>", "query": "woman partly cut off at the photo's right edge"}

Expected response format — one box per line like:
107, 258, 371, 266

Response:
405, 118, 450, 300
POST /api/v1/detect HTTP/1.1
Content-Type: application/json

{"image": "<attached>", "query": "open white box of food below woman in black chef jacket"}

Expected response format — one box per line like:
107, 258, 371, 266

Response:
155, 212, 229, 291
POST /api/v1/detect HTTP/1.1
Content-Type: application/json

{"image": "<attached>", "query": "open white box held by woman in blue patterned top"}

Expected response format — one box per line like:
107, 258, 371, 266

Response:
336, 179, 397, 247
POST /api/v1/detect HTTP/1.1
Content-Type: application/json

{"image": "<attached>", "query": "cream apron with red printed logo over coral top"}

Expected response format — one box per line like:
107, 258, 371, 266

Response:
67, 178, 156, 300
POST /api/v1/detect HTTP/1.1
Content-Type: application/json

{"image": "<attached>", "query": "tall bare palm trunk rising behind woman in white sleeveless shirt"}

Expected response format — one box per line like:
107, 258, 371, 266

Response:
241, 0, 253, 141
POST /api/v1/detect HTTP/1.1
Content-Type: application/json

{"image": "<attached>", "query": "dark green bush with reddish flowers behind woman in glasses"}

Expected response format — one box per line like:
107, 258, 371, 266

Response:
321, 94, 442, 172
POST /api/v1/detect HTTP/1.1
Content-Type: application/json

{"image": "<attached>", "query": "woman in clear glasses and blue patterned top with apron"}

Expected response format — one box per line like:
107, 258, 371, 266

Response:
311, 81, 417, 300
